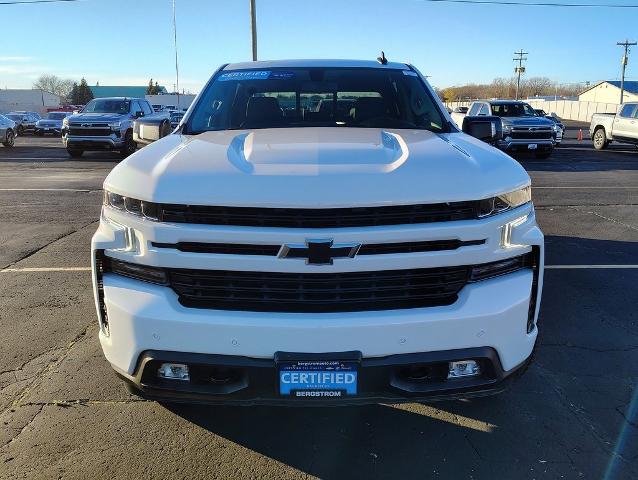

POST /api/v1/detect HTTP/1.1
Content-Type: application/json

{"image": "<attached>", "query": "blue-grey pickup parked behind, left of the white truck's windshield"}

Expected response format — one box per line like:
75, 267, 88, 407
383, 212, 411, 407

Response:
62, 97, 154, 158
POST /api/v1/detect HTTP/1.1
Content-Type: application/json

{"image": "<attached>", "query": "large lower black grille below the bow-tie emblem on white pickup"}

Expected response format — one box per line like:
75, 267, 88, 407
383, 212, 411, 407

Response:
166, 266, 471, 312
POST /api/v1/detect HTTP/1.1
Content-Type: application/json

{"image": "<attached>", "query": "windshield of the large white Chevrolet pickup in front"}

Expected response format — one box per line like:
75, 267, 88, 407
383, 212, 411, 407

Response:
184, 67, 448, 134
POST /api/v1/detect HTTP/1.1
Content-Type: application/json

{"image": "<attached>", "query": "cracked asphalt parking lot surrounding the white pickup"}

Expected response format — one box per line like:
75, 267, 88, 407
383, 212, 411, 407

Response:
0, 125, 638, 479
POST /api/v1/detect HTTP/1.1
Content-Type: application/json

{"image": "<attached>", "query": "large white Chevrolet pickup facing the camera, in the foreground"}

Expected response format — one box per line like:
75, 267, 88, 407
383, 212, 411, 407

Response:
92, 61, 543, 404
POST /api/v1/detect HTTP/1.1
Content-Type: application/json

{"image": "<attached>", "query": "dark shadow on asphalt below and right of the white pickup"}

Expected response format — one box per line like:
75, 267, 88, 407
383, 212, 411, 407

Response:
164, 236, 638, 479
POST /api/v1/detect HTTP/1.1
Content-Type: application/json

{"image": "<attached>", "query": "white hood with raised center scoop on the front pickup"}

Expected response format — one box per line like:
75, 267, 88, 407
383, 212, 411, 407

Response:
104, 127, 530, 208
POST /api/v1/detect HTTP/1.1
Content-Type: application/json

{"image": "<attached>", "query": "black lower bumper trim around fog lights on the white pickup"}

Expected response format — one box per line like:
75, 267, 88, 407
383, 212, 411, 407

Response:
119, 347, 532, 406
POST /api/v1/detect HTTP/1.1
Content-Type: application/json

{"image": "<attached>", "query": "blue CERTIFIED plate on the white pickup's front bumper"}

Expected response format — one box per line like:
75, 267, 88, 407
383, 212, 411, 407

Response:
279, 360, 358, 398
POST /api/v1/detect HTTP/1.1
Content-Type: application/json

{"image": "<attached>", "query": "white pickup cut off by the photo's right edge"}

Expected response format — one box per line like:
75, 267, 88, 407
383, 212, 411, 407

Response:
589, 102, 638, 150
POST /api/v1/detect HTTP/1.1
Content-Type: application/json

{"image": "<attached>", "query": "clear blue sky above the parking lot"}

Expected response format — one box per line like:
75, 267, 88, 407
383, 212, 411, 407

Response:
0, 0, 638, 93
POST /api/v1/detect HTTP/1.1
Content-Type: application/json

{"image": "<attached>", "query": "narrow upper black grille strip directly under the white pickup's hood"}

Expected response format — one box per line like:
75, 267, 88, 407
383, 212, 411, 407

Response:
159, 201, 480, 228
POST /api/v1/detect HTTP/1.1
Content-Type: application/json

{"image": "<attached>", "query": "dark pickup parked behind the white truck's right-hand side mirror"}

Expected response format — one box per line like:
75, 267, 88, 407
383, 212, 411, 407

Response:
466, 100, 556, 158
